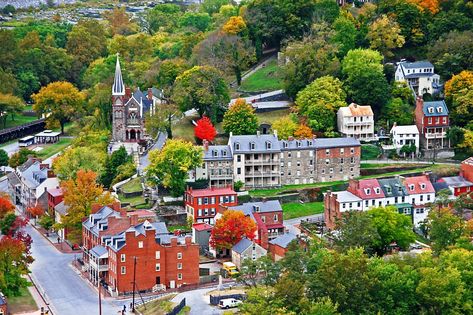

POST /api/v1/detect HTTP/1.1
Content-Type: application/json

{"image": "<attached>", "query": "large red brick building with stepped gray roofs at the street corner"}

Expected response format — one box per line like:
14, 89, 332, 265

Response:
82, 204, 199, 295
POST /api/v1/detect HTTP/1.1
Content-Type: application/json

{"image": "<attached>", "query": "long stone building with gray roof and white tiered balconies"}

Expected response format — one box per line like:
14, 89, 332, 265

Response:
196, 132, 361, 189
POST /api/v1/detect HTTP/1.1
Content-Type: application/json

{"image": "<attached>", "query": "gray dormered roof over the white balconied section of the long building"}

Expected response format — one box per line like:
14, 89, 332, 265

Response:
228, 134, 281, 154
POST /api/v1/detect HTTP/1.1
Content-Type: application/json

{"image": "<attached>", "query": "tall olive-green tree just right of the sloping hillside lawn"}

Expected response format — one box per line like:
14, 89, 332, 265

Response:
284, 24, 340, 98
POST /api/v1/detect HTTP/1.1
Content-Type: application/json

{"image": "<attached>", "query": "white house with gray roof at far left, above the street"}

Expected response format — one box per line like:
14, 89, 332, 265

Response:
8, 158, 59, 211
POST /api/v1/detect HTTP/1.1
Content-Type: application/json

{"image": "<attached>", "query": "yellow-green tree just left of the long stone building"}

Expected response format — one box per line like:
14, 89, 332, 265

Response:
146, 139, 202, 196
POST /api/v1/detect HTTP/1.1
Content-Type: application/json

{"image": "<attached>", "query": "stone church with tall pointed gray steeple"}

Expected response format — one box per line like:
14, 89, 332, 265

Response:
112, 54, 163, 147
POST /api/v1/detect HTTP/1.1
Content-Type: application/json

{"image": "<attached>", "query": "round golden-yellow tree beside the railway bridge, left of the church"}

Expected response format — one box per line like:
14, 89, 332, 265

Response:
33, 82, 85, 133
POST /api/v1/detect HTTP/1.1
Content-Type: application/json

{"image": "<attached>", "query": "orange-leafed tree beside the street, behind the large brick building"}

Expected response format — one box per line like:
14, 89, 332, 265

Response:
58, 170, 114, 243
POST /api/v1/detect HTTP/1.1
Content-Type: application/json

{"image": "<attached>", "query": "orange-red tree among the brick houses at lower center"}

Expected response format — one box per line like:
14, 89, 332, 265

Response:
210, 210, 256, 249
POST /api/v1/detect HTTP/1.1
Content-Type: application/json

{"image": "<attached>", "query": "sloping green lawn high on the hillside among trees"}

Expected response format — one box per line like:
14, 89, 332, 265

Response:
240, 59, 283, 92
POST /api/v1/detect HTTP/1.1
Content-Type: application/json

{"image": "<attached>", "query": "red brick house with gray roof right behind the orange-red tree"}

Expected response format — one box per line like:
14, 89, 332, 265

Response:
215, 200, 285, 249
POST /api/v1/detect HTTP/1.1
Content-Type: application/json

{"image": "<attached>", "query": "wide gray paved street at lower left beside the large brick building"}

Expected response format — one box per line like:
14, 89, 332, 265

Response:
26, 226, 120, 315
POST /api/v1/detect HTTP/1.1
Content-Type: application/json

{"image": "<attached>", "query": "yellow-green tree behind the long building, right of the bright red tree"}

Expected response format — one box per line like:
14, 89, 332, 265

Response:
222, 99, 258, 135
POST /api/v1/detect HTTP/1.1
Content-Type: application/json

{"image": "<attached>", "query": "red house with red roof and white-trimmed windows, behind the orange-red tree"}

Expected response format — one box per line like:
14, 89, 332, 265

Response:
184, 187, 238, 225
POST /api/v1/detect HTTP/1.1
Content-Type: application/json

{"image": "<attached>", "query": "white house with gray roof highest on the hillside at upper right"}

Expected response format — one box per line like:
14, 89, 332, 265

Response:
394, 61, 441, 96
